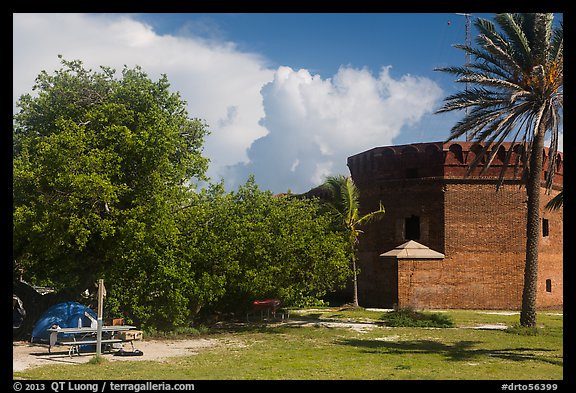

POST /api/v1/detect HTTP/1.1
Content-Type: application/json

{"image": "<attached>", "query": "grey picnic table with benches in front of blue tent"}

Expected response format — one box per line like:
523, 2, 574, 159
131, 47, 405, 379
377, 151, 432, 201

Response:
48, 325, 142, 357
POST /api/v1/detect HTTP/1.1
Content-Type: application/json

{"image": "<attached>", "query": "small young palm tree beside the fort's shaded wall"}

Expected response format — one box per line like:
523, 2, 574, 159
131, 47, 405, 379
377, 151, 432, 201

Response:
321, 175, 385, 307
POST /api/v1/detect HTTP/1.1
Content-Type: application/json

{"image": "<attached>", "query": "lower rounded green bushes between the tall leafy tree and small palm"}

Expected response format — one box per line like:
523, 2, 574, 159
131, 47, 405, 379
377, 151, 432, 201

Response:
100, 179, 350, 328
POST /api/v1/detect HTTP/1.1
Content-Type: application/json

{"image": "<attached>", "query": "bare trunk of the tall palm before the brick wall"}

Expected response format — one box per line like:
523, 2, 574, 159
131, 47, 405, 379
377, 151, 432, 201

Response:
520, 128, 545, 327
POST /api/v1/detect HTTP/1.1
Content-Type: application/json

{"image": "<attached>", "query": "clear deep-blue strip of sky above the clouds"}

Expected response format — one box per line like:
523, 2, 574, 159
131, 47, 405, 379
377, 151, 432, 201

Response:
134, 13, 472, 77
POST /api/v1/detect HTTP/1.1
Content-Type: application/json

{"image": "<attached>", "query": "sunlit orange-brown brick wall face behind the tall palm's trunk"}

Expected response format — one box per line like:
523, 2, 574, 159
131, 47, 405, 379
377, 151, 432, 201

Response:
438, 183, 563, 309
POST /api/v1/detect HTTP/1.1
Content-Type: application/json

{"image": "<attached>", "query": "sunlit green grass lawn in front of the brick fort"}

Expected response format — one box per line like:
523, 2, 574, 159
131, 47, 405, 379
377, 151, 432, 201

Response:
14, 309, 563, 380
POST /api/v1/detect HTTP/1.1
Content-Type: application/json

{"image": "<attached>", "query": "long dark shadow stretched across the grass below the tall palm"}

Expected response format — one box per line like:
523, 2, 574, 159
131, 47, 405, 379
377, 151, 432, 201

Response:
338, 339, 563, 366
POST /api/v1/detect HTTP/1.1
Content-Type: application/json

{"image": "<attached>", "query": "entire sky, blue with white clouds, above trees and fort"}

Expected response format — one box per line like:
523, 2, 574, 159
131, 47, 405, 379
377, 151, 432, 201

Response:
13, 13, 564, 192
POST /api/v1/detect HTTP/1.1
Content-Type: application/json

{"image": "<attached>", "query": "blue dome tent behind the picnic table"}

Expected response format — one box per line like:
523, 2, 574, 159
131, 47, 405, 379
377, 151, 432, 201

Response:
30, 302, 97, 344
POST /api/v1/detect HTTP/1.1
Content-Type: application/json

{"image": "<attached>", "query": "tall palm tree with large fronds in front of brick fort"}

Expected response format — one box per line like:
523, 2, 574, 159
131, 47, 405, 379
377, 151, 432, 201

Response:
437, 14, 564, 327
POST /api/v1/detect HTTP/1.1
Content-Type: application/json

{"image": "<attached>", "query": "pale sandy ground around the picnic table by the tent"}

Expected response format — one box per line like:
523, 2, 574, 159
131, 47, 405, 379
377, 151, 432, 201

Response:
12, 338, 217, 372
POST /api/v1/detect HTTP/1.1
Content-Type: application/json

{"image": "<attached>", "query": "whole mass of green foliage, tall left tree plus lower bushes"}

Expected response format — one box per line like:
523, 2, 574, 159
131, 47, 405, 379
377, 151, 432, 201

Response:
13, 60, 349, 329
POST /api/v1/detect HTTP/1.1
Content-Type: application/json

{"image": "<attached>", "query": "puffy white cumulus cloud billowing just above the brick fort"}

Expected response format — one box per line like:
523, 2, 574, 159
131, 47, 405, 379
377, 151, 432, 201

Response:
226, 67, 442, 192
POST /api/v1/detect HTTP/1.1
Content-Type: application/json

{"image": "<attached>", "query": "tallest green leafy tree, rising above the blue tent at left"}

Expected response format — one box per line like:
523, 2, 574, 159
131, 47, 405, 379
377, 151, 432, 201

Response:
13, 60, 208, 326
